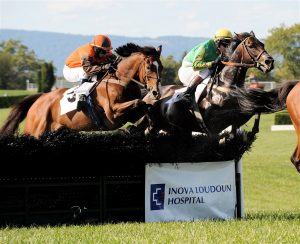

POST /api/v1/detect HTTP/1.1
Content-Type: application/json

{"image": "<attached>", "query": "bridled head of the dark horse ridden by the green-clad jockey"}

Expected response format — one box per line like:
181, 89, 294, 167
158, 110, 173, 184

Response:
221, 31, 274, 84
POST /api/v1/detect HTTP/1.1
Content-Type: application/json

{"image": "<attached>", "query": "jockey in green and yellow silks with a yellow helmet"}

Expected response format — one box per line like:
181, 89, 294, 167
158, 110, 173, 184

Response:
178, 28, 232, 92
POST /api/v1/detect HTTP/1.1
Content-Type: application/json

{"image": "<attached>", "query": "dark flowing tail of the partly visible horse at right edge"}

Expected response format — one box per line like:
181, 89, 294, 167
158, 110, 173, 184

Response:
227, 88, 286, 115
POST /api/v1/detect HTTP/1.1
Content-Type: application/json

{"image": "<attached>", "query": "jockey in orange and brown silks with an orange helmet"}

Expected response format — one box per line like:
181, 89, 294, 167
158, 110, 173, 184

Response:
63, 35, 116, 110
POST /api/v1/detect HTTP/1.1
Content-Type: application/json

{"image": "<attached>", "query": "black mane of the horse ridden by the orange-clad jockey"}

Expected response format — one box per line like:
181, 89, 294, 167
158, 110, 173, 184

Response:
115, 42, 159, 57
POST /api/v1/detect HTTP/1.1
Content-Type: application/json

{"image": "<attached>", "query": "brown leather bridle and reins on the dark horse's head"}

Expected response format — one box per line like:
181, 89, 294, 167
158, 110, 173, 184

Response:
221, 36, 266, 68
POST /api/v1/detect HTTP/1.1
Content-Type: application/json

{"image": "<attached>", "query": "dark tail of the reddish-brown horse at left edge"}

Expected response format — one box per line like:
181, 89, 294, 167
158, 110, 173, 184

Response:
0, 93, 43, 135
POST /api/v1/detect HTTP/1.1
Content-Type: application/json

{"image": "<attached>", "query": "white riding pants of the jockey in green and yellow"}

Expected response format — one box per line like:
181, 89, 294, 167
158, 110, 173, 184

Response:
178, 62, 212, 86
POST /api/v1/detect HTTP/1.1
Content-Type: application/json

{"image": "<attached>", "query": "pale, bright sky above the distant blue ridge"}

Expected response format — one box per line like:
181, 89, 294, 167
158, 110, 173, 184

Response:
0, 0, 300, 38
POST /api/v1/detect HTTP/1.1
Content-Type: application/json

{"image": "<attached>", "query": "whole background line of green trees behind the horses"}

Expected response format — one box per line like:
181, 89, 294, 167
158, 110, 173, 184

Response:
0, 23, 300, 92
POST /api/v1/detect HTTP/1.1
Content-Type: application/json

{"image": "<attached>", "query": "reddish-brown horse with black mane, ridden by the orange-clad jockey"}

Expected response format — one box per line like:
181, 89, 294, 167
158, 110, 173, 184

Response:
0, 43, 163, 138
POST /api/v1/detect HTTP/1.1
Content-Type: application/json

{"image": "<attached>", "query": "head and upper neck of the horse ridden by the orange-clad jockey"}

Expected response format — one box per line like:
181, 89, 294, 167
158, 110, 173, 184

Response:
116, 43, 163, 100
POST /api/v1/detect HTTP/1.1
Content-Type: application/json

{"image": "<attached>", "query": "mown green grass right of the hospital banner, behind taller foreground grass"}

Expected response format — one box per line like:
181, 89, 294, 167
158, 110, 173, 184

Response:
242, 114, 300, 211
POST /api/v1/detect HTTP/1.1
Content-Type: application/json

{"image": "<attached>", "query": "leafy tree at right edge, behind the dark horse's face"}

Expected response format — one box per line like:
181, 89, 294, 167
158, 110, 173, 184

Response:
265, 23, 300, 80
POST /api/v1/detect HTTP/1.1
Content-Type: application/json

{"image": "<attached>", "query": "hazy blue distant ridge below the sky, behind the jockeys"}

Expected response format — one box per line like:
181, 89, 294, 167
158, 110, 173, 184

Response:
0, 29, 207, 76
